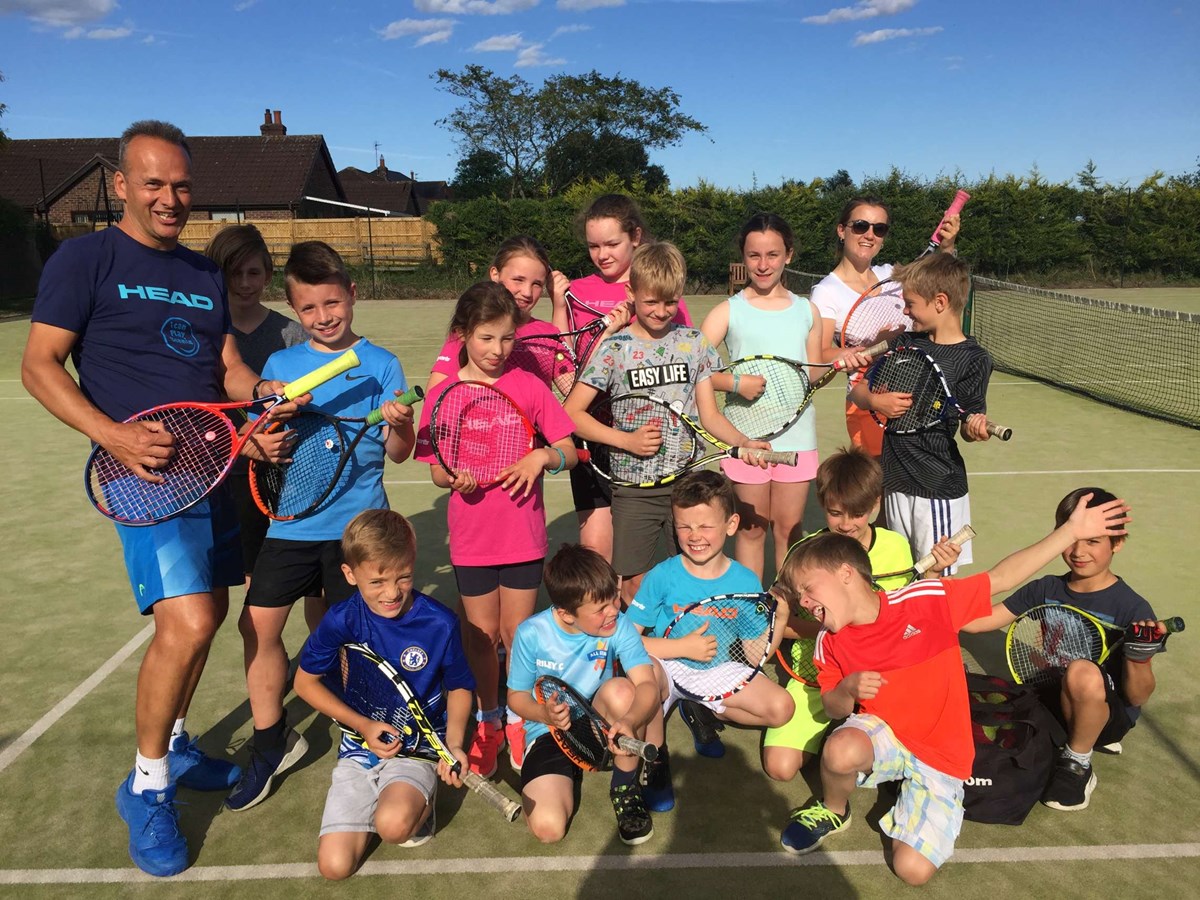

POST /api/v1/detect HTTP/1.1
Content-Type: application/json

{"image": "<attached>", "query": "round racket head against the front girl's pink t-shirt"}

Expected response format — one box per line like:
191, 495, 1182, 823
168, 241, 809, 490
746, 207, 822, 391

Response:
430, 382, 534, 487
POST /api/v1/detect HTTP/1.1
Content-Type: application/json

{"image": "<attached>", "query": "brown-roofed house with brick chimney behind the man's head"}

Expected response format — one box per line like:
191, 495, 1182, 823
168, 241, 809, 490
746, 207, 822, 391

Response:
0, 109, 353, 226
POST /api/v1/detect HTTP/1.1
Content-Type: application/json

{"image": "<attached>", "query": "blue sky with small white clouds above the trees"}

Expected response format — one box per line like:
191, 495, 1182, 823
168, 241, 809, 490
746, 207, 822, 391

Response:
0, 0, 1200, 188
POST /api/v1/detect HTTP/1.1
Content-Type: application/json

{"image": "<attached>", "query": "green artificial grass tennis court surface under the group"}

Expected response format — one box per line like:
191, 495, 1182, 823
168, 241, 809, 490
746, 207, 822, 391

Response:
0, 298, 1200, 900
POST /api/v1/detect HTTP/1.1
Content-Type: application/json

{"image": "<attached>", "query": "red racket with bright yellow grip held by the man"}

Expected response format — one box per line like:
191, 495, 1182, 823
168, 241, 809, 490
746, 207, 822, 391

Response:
83, 350, 359, 526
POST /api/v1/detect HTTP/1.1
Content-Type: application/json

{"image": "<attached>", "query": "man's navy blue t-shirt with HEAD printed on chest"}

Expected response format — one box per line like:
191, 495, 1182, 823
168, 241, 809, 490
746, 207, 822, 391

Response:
32, 228, 233, 421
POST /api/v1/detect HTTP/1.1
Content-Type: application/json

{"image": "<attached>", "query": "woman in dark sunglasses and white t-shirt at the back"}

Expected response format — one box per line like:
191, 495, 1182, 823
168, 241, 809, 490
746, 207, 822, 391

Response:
811, 197, 960, 458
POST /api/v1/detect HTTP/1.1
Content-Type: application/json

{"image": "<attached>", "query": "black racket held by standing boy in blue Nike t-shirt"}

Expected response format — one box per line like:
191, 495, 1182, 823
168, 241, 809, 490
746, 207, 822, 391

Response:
250, 386, 425, 522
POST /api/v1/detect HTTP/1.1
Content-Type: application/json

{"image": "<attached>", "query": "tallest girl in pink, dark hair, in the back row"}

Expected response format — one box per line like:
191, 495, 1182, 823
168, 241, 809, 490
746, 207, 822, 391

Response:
552, 193, 691, 560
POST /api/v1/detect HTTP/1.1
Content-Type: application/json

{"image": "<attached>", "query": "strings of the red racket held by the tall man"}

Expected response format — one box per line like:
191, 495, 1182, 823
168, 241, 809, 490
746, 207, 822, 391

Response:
88, 407, 238, 522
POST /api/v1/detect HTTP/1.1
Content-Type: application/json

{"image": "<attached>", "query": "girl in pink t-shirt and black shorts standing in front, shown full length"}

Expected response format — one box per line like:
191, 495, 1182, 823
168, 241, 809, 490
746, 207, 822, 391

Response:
413, 281, 578, 776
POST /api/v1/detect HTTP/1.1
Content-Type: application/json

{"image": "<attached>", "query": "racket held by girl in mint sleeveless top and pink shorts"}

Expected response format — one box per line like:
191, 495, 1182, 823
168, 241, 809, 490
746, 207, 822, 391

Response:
718, 341, 888, 440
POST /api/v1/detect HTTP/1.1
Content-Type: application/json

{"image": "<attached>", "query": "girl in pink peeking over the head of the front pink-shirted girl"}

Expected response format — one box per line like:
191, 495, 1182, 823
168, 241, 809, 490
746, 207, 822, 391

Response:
425, 234, 569, 394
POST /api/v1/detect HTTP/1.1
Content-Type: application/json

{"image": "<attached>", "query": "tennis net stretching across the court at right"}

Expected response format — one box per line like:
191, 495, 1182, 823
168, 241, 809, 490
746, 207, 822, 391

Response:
787, 269, 1200, 428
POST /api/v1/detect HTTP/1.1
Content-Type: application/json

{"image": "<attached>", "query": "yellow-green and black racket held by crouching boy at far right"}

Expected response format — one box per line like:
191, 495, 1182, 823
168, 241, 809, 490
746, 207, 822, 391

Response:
1004, 604, 1183, 685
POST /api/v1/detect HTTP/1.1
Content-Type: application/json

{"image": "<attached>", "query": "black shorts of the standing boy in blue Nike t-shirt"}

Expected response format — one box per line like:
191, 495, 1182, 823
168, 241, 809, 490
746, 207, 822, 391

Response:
246, 538, 356, 607
